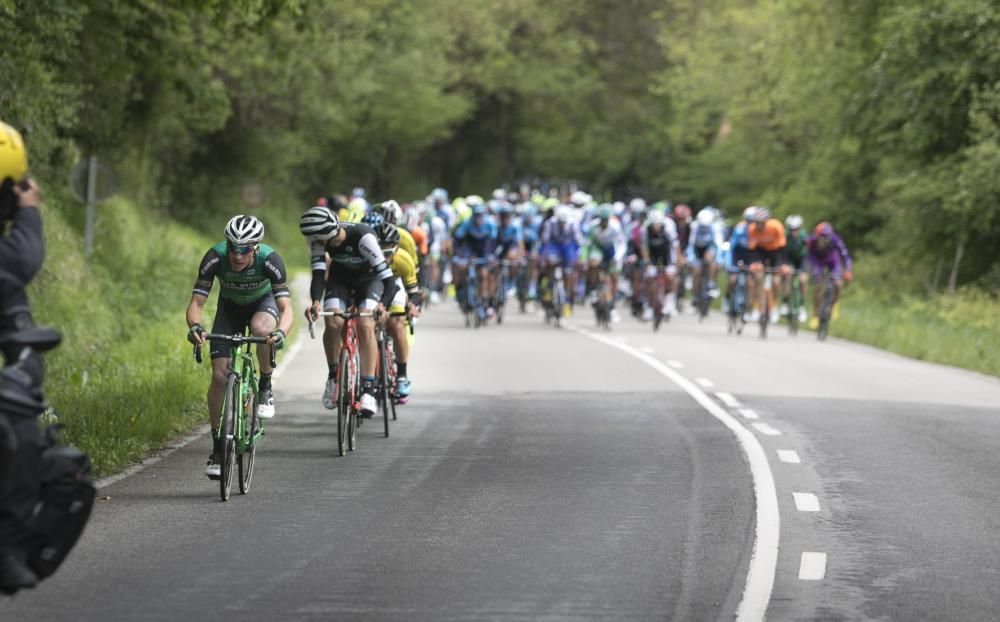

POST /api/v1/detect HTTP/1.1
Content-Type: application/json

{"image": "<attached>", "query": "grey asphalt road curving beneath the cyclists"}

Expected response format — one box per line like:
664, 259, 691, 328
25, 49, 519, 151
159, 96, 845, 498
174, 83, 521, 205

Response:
0, 294, 1000, 621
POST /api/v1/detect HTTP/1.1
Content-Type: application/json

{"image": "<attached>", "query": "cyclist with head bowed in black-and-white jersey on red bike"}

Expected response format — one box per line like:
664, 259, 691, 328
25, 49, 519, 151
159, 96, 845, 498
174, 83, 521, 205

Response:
299, 206, 397, 417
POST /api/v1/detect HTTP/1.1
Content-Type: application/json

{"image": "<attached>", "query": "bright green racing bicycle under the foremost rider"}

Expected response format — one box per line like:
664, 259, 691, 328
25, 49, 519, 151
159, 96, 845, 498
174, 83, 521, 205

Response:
194, 333, 277, 501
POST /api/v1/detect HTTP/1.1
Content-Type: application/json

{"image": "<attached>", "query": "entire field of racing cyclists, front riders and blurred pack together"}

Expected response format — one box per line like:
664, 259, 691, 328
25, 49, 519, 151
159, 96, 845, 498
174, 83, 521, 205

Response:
187, 183, 851, 478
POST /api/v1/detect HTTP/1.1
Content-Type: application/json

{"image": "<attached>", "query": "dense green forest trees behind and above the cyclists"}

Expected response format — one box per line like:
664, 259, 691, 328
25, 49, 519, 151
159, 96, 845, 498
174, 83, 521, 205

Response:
0, 0, 1000, 292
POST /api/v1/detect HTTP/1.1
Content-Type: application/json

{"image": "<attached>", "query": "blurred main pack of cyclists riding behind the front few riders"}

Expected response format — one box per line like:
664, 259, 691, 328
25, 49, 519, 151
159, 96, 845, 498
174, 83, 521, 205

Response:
386, 188, 852, 328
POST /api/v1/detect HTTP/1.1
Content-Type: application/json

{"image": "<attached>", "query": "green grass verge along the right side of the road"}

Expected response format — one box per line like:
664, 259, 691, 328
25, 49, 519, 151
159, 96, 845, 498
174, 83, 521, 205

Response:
830, 286, 1000, 376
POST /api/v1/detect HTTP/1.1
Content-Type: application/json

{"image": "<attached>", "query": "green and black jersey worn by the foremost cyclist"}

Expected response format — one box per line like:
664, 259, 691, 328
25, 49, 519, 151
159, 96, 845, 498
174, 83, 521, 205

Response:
194, 241, 289, 306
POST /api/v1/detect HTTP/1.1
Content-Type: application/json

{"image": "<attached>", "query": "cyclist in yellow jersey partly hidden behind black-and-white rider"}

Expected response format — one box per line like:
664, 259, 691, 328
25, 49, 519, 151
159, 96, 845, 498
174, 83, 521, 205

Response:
375, 222, 423, 404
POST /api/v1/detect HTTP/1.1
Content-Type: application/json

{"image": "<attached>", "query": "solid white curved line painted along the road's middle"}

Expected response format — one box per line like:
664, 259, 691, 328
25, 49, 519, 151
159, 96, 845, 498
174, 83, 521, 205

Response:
567, 326, 781, 622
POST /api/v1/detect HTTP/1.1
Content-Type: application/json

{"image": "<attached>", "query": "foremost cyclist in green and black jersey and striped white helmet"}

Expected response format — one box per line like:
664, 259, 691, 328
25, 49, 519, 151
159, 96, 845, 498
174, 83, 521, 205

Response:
187, 217, 292, 479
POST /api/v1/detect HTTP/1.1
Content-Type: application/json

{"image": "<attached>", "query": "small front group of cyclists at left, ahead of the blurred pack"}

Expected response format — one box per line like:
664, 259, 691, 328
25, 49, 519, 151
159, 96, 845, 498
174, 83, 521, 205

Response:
187, 191, 422, 479
